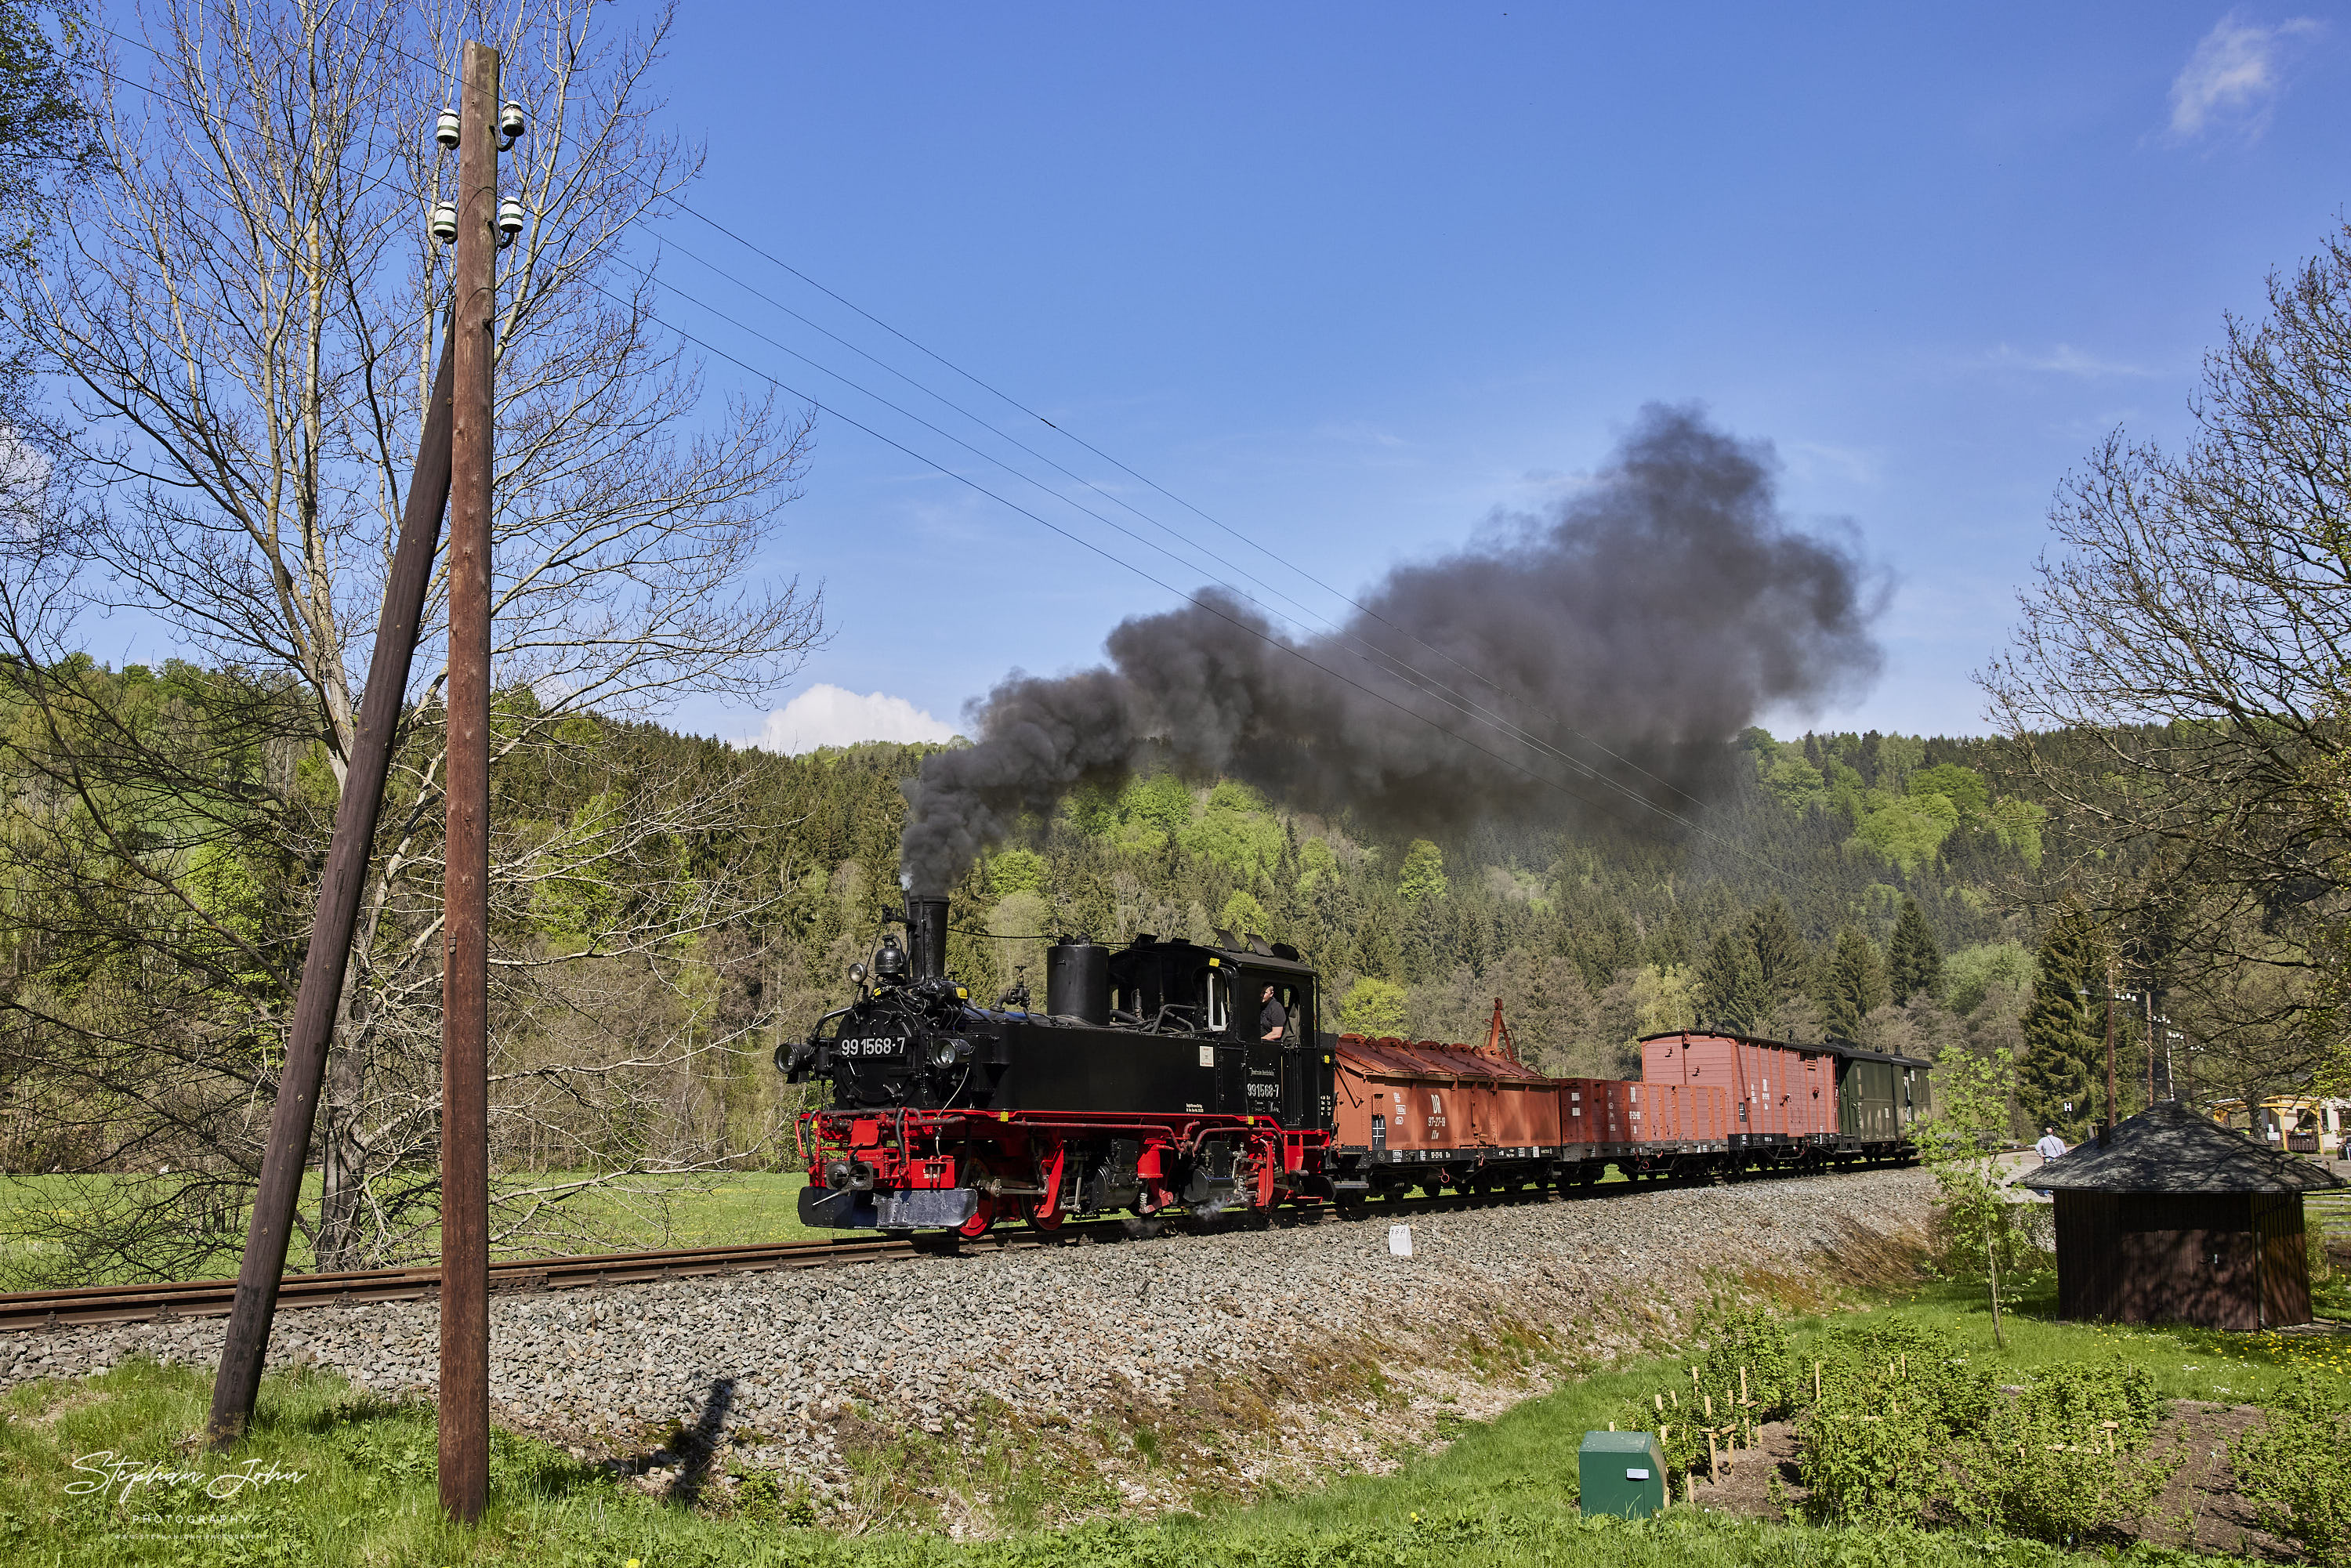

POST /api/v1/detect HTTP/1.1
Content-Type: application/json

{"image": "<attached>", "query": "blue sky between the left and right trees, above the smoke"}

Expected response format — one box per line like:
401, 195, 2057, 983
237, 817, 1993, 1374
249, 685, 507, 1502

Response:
635, 2, 2351, 743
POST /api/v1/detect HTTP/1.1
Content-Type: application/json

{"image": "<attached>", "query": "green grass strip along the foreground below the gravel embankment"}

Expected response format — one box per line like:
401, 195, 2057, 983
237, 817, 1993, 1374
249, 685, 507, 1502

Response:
0, 1302, 2257, 1568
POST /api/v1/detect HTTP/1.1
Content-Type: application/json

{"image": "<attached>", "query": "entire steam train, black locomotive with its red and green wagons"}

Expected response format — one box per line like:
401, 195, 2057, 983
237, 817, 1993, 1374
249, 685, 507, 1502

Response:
776, 898, 1930, 1237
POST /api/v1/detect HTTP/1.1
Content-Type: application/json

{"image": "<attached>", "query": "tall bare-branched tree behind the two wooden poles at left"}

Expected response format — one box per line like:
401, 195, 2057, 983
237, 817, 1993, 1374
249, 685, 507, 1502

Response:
0, 0, 820, 1272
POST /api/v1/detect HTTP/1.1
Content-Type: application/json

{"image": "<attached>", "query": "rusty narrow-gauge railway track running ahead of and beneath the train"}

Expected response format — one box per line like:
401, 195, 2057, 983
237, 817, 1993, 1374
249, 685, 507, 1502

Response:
0, 1180, 1871, 1333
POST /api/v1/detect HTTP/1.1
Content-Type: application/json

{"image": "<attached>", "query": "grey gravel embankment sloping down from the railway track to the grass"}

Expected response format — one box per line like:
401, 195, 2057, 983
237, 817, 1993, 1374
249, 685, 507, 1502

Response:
0, 1171, 1933, 1528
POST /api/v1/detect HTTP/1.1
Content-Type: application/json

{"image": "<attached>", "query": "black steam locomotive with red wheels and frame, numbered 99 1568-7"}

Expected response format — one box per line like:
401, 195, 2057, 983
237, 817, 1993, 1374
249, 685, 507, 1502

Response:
778, 898, 1338, 1234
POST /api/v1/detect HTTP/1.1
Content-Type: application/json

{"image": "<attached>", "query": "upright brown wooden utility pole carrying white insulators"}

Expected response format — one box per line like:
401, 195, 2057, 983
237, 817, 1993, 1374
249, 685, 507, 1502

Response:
440, 42, 498, 1523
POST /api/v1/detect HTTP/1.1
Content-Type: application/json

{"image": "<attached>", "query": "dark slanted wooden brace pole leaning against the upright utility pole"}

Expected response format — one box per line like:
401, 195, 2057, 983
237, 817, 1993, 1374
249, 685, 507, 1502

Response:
205, 313, 451, 1448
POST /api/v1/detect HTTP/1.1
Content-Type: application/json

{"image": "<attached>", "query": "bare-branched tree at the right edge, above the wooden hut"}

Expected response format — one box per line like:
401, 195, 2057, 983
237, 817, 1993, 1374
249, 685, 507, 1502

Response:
1980, 217, 2351, 1095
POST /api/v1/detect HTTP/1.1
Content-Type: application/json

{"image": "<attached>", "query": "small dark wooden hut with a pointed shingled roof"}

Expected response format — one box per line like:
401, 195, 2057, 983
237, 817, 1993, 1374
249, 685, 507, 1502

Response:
2015, 1105, 2344, 1331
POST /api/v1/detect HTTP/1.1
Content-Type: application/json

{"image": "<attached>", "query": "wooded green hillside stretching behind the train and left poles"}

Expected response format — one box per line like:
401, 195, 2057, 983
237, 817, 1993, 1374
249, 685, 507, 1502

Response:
0, 661, 2083, 1276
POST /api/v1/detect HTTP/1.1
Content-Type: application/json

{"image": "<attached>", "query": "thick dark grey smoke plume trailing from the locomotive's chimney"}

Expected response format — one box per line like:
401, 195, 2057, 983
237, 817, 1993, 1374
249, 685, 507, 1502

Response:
900, 407, 1883, 893
